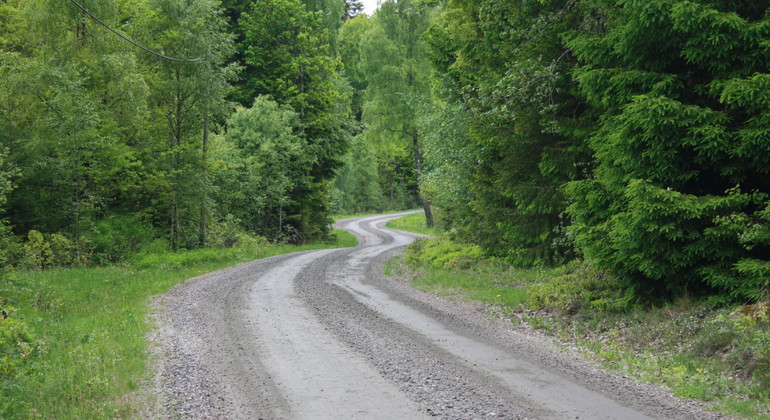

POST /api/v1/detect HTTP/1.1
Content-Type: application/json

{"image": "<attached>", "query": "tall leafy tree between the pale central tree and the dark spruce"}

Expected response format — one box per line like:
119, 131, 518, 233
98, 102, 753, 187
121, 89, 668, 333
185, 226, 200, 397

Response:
426, 0, 585, 265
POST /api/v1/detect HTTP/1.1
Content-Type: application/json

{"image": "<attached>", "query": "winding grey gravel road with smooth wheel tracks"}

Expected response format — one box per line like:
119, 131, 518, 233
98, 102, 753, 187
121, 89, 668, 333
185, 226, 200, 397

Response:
150, 214, 718, 419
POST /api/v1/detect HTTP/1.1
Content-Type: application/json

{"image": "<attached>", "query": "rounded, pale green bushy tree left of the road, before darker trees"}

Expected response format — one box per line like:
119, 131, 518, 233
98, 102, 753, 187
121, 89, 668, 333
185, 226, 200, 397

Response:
215, 96, 314, 240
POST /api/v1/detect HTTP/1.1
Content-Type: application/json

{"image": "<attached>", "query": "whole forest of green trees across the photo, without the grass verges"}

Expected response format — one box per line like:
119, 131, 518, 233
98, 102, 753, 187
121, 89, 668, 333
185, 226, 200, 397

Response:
0, 0, 770, 302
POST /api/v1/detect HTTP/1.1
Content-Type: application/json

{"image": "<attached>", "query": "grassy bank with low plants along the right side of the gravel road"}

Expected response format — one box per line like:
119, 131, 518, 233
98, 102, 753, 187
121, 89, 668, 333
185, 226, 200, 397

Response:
387, 217, 770, 419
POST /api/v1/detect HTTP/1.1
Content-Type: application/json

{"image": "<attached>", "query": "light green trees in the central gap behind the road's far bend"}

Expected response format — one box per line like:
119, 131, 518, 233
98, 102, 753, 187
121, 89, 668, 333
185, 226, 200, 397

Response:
334, 0, 433, 214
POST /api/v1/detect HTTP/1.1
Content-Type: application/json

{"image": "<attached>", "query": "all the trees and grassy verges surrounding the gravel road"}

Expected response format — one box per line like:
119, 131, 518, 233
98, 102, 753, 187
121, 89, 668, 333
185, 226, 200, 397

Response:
0, 0, 770, 419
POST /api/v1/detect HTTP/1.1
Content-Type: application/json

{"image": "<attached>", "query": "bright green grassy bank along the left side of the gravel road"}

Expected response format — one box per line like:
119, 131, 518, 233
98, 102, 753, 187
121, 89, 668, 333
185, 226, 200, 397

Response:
0, 231, 356, 419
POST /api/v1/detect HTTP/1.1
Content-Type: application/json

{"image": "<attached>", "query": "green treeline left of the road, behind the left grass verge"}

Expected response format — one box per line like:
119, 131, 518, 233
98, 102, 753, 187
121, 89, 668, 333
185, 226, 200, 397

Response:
0, 0, 361, 267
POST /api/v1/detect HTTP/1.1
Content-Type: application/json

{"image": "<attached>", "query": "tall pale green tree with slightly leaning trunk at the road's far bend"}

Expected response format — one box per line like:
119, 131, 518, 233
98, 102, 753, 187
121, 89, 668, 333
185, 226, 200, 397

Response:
360, 0, 433, 226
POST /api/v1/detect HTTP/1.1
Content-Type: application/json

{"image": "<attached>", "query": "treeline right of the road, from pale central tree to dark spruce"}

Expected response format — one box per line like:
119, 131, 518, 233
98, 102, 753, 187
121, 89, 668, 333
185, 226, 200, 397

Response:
338, 0, 770, 301
